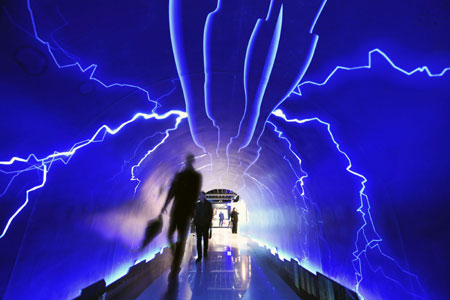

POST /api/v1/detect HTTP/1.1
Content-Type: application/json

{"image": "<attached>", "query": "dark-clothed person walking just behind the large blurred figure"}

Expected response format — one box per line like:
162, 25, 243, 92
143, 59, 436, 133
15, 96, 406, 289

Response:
194, 192, 213, 262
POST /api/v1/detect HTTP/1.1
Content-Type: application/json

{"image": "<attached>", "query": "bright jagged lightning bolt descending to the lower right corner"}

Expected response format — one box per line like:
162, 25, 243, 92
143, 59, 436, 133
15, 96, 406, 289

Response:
273, 109, 424, 298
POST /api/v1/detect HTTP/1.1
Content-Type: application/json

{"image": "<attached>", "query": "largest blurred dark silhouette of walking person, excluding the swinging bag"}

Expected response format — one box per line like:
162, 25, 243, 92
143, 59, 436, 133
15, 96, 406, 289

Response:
161, 154, 202, 280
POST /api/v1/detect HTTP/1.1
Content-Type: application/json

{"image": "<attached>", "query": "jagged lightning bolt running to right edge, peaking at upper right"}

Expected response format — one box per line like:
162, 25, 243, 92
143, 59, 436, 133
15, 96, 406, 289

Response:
293, 48, 450, 95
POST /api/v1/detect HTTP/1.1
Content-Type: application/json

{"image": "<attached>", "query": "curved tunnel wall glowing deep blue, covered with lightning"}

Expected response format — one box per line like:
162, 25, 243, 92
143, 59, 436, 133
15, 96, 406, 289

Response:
0, 1, 450, 299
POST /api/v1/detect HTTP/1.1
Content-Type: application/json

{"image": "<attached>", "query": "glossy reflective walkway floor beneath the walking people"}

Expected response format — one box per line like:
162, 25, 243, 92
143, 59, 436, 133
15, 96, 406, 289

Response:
137, 228, 299, 300
